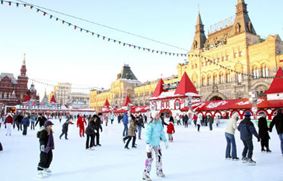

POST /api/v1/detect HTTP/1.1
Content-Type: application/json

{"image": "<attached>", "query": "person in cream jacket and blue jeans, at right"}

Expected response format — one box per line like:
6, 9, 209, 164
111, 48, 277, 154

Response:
225, 114, 239, 160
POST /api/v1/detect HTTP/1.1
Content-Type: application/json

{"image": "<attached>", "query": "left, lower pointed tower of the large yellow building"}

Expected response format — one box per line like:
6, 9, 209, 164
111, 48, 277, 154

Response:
191, 13, 206, 50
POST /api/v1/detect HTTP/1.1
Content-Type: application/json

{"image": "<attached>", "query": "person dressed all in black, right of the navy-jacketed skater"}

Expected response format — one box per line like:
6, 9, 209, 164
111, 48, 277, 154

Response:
258, 113, 271, 152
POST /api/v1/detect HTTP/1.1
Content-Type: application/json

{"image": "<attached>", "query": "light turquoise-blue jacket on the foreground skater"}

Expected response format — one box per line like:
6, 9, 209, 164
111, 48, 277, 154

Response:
145, 120, 167, 146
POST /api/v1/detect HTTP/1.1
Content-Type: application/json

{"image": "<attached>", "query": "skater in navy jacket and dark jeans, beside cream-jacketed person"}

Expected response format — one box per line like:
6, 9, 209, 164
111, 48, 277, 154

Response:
238, 112, 260, 165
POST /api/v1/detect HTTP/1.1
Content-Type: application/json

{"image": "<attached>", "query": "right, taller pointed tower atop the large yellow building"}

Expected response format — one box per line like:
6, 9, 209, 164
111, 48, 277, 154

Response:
230, 0, 256, 36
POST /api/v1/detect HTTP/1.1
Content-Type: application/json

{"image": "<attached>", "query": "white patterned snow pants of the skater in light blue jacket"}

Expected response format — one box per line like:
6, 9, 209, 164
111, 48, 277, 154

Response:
144, 146, 162, 173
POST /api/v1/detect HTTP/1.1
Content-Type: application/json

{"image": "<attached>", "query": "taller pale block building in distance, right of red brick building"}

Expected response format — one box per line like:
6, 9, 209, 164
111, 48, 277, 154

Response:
53, 82, 72, 105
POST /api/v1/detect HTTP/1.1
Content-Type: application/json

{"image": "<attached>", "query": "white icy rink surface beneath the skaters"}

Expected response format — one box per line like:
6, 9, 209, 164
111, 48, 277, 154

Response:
0, 120, 283, 181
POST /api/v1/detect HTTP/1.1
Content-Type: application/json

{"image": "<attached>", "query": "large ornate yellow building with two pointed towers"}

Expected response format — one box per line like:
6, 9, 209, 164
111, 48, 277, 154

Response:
177, 0, 283, 100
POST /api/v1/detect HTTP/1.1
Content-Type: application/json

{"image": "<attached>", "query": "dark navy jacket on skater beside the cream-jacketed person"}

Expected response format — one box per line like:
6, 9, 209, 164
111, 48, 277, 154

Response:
238, 118, 259, 140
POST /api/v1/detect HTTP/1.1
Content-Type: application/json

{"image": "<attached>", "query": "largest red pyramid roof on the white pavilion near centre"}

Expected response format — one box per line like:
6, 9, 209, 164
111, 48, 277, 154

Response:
175, 72, 198, 95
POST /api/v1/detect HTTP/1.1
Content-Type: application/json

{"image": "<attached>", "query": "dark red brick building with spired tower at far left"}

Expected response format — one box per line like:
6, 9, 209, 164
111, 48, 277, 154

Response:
0, 58, 28, 106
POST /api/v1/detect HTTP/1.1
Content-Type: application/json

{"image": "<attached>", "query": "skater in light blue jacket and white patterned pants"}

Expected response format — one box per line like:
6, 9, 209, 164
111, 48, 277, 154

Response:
143, 112, 168, 181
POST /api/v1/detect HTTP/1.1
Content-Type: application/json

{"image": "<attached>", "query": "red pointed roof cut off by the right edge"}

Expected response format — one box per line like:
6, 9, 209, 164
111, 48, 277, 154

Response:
265, 68, 283, 94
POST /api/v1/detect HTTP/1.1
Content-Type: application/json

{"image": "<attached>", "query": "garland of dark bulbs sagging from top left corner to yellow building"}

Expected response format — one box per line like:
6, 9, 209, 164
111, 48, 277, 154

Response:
0, 0, 190, 57
